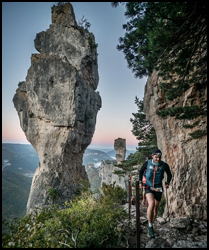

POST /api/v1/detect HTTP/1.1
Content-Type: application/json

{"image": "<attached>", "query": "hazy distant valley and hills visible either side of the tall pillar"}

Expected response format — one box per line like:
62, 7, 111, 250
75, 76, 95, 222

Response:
2, 143, 134, 231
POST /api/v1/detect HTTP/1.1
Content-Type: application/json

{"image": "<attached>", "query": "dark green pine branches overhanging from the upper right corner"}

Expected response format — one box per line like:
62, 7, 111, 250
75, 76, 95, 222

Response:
112, 2, 207, 119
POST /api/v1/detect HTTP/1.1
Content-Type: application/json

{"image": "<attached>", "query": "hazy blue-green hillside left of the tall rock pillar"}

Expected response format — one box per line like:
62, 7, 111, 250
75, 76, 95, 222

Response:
2, 143, 39, 232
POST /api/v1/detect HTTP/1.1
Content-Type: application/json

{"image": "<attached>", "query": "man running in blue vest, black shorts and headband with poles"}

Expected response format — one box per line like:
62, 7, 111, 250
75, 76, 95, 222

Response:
139, 149, 172, 238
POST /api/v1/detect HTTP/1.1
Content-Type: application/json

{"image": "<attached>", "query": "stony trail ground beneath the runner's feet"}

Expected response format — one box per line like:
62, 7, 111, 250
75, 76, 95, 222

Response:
124, 203, 207, 248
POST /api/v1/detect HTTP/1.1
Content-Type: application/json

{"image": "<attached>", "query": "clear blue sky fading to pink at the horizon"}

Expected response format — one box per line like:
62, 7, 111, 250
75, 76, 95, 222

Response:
2, 2, 147, 150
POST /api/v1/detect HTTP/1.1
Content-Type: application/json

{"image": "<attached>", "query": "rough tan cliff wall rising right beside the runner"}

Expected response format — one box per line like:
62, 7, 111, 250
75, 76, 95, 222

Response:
144, 72, 207, 219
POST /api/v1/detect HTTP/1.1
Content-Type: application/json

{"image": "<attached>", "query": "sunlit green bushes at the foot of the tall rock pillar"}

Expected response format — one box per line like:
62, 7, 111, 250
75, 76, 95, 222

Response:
2, 188, 128, 248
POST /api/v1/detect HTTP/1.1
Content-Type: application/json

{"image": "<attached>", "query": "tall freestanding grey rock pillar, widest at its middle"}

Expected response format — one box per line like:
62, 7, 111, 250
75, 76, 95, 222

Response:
13, 3, 101, 213
